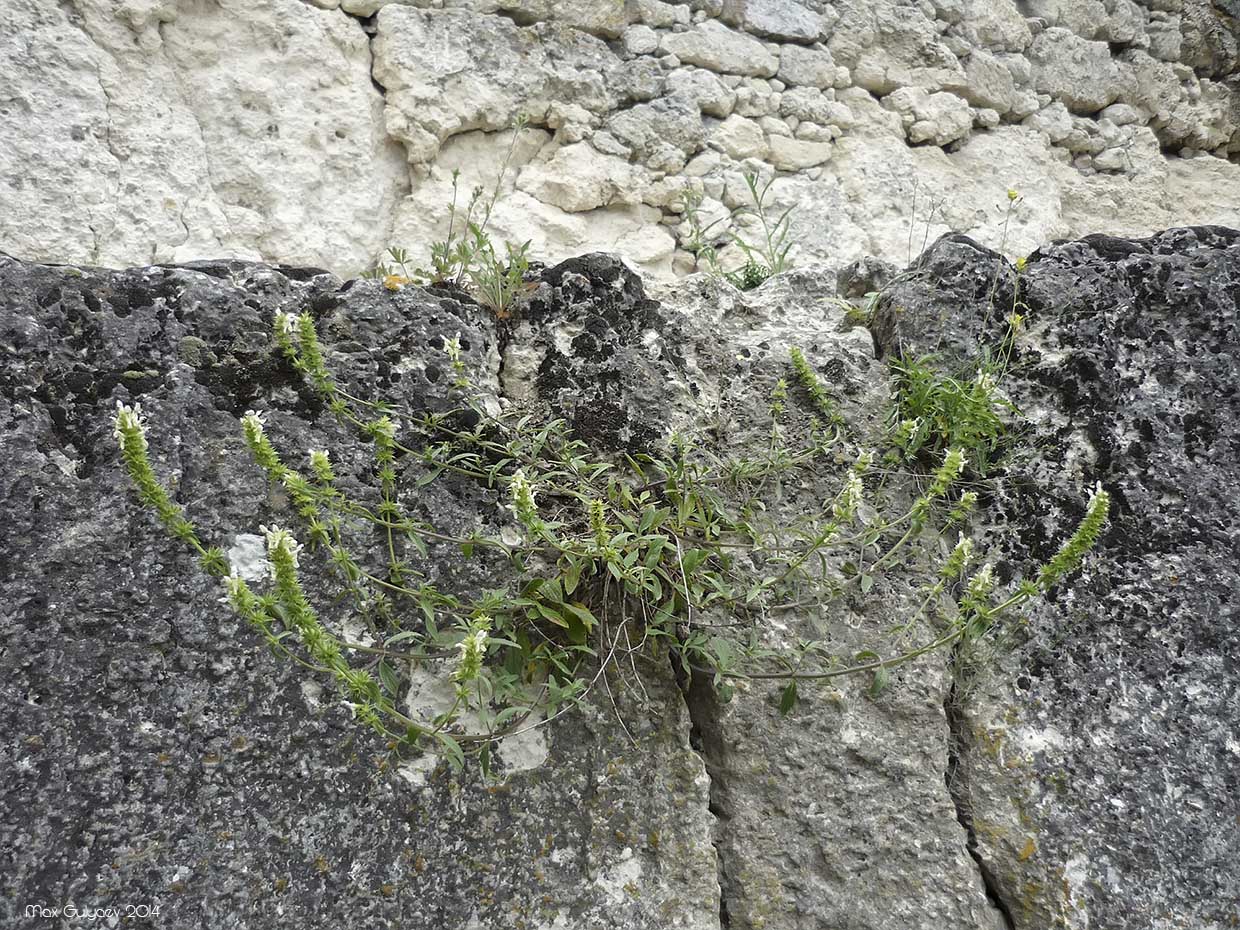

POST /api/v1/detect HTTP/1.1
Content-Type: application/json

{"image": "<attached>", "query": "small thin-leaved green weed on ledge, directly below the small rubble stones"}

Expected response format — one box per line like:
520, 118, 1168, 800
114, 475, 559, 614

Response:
681, 172, 794, 290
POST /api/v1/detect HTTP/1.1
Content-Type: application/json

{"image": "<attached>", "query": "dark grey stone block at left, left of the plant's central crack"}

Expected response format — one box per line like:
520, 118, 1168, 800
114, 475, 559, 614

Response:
0, 252, 718, 930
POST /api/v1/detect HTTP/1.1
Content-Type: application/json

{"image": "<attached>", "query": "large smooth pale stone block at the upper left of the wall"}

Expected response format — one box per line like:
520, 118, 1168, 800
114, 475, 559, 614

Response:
0, 0, 408, 272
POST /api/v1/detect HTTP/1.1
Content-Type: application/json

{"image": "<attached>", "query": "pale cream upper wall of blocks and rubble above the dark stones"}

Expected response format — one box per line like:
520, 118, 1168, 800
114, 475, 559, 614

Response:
0, 0, 1240, 275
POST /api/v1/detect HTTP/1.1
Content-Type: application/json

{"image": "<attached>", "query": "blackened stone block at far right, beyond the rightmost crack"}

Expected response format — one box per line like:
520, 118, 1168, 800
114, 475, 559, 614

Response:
875, 228, 1240, 930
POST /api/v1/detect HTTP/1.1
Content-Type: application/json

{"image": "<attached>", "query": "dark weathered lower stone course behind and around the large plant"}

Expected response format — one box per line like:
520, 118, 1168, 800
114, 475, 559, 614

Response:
0, 228, 1240, 930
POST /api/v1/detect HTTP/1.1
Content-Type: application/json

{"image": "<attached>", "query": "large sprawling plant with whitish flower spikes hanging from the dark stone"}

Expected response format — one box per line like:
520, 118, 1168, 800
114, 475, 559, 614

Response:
114, 314, 1109, 770
